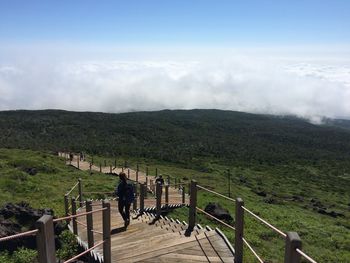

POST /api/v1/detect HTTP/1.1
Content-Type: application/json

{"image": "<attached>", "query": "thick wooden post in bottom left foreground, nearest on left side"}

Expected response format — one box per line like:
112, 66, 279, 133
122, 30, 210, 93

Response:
35, 215, 56, 263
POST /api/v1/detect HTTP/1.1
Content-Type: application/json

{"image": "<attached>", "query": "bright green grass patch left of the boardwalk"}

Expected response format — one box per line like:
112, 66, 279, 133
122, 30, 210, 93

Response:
0, 149, 116, 216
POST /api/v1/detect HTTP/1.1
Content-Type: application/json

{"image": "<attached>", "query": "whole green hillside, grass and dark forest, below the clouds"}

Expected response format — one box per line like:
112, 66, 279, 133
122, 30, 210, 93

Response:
0, 110, 350, 262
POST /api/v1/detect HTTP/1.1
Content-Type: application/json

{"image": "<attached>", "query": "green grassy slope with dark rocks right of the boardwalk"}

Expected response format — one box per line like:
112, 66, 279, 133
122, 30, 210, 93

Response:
80, 156, 350, 262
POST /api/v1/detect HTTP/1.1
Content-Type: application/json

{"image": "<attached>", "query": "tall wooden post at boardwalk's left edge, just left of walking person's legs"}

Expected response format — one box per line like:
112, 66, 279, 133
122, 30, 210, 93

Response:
102, 201, 112, 263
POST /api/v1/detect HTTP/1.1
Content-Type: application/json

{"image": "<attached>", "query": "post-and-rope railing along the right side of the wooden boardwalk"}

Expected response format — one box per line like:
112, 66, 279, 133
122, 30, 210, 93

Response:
57, 155, 317, 263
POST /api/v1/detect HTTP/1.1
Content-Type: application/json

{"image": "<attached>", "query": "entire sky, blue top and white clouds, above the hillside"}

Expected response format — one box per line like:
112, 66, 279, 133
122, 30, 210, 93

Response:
0, 0, 350, 119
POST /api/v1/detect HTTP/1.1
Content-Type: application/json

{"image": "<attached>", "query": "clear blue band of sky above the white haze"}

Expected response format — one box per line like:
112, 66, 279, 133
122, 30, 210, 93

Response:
0, 0, 350, 46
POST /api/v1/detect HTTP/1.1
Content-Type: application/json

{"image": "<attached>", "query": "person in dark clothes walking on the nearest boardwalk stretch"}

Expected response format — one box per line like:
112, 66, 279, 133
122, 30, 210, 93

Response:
116, 172, 135, 228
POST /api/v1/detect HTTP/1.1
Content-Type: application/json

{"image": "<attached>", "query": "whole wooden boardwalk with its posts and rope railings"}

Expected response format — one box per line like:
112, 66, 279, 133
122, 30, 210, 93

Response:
0, 153, 317, 263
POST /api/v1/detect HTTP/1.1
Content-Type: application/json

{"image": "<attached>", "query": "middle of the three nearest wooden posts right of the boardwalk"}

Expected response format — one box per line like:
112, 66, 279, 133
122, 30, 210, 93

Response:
235, 197, 244, 263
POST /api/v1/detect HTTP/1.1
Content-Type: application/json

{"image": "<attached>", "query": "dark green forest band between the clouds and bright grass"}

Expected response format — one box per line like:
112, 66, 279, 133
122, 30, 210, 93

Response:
0, 110, 350, 168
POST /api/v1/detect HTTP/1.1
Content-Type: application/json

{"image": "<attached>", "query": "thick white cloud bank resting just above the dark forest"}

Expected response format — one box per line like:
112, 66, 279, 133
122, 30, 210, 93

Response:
0, 54, 350, 122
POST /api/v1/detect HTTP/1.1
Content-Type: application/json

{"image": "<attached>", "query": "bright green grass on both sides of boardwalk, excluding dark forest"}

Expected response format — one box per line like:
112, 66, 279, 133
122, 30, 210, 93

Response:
0, 149, 350, 262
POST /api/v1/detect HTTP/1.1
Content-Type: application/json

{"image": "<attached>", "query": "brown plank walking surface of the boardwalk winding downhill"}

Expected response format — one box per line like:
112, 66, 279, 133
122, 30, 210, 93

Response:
61, 154, 234, 263
